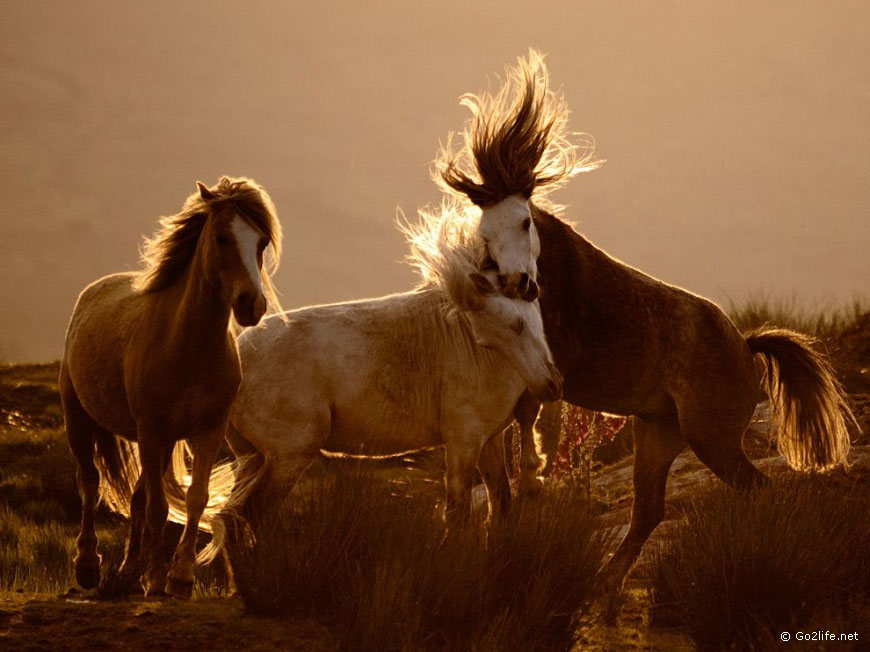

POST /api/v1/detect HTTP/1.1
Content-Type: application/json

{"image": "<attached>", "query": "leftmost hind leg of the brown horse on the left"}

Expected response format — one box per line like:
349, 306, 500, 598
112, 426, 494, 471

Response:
60, 367, 100, 589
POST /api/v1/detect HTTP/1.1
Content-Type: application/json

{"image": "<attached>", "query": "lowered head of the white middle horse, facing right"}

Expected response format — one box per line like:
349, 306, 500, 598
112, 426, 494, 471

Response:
465, 272, 562, 401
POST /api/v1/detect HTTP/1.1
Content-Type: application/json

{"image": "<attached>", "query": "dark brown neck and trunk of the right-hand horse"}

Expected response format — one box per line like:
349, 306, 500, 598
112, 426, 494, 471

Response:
535, 206, 755, 414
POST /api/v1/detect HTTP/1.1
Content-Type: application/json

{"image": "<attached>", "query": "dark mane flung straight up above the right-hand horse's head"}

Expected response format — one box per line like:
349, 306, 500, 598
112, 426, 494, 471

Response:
432, 50, 602, 206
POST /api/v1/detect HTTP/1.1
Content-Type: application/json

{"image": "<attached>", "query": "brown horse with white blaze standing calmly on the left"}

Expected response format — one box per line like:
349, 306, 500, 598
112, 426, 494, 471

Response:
60, 177, 281, 597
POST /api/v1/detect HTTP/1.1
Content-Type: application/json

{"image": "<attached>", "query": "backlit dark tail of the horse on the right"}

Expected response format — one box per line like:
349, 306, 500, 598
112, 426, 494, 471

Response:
746, 328, 858, 471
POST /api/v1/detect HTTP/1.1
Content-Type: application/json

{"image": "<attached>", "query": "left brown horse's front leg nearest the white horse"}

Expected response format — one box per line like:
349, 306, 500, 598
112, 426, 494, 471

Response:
166, 422, 226, 600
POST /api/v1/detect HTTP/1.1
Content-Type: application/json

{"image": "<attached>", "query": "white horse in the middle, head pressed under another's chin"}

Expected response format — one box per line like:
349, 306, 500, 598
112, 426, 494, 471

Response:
187, 202, 561, 559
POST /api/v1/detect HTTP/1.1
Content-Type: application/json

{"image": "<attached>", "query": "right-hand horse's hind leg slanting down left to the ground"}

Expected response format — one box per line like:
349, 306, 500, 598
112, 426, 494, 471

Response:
601, 417, 686, 590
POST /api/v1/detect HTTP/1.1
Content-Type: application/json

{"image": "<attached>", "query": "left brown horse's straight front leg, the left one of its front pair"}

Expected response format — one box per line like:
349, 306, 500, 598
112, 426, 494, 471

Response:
138, 428, 175, 596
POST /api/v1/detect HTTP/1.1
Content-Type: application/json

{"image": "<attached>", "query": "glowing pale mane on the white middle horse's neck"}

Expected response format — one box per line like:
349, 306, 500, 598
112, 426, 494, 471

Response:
398, 196, 485, 310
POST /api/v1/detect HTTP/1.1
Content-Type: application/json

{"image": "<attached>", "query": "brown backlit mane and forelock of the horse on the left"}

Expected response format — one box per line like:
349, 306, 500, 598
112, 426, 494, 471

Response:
136, 176, 281, 309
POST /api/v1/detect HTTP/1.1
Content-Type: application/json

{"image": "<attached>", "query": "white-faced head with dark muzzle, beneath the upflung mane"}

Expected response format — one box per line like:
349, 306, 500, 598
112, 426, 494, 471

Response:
478, 195, 541, 301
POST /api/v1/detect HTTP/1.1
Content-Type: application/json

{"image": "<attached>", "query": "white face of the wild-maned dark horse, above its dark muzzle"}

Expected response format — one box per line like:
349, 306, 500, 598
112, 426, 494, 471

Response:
478, 195, 541, 283
